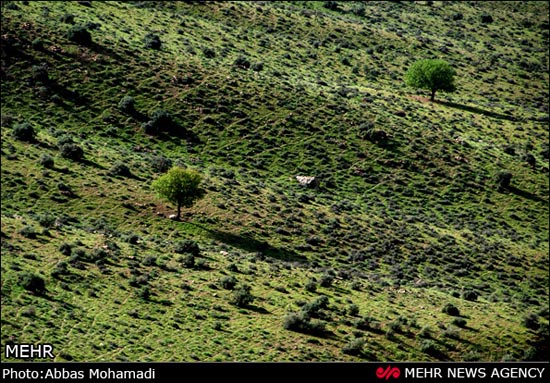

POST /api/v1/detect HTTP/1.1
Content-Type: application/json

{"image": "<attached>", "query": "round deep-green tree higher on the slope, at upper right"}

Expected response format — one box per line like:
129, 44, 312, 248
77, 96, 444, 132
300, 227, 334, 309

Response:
405, 60, 456, 101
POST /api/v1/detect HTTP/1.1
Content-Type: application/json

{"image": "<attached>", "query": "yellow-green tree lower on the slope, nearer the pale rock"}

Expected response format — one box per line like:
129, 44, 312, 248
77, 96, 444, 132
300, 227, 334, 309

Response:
152, 166, 205, 220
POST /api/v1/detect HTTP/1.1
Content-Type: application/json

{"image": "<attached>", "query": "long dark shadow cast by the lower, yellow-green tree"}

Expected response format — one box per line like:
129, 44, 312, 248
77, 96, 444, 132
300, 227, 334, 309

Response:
190, 223, 307, 262
